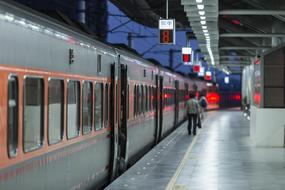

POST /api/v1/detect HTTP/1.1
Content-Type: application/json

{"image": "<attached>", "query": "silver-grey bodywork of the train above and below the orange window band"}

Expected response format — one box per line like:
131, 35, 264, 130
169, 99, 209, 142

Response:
0, 1, 207, 190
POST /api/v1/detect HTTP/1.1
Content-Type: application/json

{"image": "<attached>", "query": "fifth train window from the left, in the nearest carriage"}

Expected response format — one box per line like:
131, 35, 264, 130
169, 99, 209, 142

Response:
82, 82, 93, 135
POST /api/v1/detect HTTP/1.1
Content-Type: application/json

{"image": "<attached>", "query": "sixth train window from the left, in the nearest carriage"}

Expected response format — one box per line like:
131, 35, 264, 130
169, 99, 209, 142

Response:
94, 83, 103, 130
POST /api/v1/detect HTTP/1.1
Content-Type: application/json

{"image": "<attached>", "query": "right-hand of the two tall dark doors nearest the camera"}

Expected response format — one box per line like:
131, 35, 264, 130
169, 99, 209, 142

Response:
118, 64, 129, 172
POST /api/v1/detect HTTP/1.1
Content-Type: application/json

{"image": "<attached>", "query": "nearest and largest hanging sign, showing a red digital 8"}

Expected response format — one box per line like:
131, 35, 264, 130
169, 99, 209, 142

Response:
159, 19, 175, 44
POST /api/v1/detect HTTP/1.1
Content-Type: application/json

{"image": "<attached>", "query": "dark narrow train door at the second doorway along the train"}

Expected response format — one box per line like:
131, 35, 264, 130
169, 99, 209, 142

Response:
155, 75, 163, 143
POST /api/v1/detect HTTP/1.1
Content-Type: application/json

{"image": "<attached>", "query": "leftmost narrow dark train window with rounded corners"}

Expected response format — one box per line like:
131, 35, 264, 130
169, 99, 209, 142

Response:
8, 76, 19, 158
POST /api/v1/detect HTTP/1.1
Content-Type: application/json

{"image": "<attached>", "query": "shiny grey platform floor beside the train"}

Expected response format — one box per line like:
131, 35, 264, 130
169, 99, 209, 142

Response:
106, 109, 285, 190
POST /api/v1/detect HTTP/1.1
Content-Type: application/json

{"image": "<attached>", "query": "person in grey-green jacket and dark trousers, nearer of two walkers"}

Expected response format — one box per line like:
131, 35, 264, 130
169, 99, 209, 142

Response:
186, 93, 199, 135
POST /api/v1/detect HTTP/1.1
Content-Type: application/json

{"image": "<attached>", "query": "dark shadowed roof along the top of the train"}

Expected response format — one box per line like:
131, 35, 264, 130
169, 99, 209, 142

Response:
0, 0, 209, 81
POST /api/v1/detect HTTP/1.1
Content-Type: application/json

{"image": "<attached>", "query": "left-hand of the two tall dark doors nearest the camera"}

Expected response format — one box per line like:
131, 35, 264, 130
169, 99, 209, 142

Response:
110, 63, 118, 181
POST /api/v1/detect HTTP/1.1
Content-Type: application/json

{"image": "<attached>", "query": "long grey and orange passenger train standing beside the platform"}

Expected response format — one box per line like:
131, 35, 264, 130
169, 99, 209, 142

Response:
0, 1, 217, 190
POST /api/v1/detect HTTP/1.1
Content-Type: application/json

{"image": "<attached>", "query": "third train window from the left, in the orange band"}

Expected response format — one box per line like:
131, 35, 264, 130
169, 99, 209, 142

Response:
48, 79, 64, 144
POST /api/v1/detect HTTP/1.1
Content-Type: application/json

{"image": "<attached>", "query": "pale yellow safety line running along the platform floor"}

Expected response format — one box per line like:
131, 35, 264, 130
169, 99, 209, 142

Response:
165, 130, 200, 190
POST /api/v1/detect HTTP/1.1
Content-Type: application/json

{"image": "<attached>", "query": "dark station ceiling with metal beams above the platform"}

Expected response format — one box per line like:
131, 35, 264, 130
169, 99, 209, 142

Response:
111, 0, 285, 72
